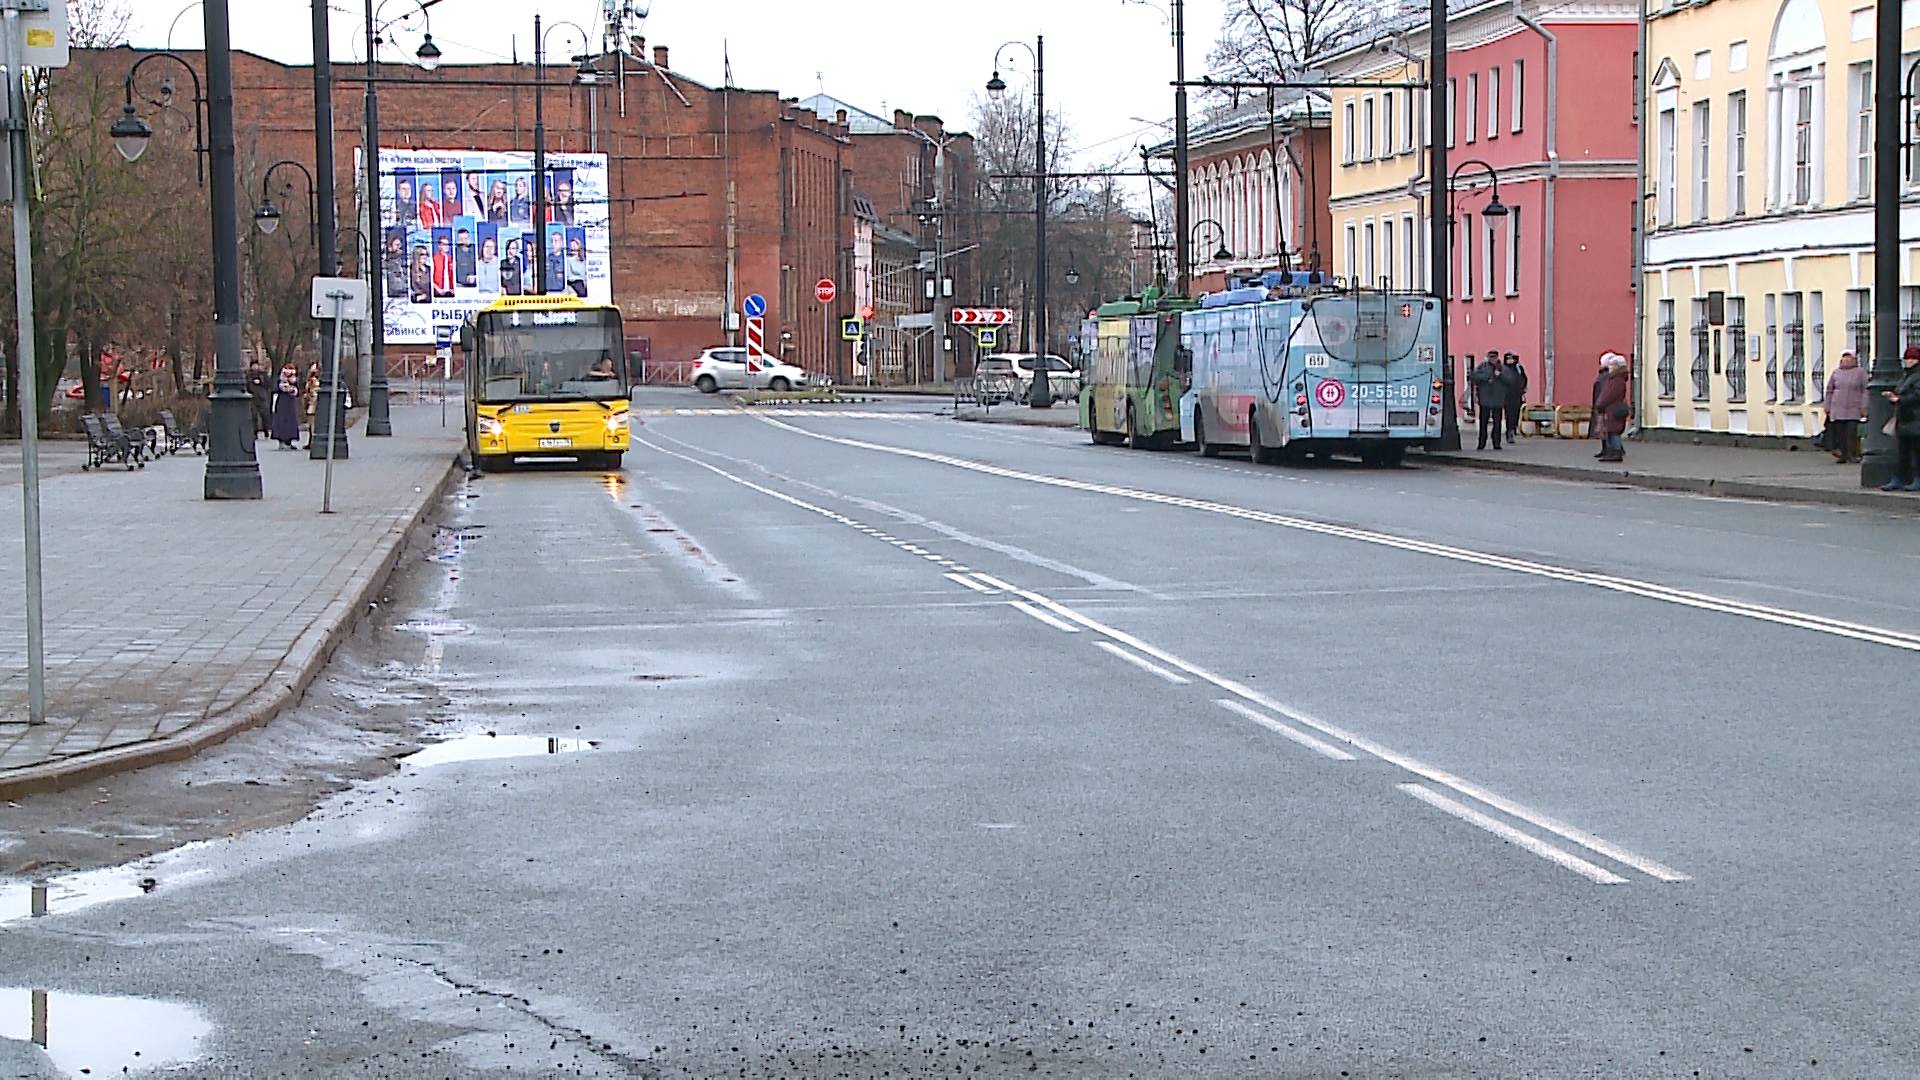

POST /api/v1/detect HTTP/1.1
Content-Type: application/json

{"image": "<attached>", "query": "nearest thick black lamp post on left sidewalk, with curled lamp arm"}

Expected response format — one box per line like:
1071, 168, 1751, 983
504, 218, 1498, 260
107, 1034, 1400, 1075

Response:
108, 24, 263, 500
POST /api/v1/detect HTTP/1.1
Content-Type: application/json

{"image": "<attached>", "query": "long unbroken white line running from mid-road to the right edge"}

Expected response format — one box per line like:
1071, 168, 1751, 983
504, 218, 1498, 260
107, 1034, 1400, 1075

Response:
764, 411, 1920, 651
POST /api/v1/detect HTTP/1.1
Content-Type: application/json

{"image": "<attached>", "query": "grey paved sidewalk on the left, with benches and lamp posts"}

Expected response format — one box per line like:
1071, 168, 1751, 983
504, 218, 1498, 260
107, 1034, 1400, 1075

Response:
0, 405, 461, 798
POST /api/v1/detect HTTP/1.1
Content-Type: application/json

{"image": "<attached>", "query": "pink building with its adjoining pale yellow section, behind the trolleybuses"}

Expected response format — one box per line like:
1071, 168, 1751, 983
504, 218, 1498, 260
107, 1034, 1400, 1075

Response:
1329, 0, 1638, 404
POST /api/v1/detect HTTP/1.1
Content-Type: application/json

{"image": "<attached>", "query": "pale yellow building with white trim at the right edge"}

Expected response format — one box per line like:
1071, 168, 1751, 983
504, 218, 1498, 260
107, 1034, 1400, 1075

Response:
1638, 0, 1920, 436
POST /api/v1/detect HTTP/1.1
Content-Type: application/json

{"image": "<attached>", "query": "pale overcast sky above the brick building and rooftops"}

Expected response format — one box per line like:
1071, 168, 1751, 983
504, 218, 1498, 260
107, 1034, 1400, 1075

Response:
129, 0, 1229, 163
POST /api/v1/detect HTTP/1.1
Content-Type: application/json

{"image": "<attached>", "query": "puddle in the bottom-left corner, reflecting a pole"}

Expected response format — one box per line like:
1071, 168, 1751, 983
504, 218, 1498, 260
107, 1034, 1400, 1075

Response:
0, 986, 213, 1076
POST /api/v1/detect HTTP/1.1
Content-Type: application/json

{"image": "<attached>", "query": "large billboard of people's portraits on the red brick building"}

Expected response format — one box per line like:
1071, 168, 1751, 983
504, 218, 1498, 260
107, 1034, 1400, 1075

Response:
359, 146, 612, 344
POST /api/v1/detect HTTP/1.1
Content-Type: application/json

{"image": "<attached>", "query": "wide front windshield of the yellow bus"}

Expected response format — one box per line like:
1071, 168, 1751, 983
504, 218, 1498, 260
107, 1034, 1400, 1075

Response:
472, 307, 626, 404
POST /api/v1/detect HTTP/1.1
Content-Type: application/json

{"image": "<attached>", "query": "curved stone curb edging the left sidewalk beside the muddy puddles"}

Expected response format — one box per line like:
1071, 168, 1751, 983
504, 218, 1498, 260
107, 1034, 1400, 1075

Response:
0, 455, 465, 799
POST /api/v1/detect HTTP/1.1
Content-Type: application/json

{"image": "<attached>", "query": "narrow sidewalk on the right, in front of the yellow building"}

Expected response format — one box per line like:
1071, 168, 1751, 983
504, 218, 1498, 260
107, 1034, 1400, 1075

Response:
1413, 427, 1920, 513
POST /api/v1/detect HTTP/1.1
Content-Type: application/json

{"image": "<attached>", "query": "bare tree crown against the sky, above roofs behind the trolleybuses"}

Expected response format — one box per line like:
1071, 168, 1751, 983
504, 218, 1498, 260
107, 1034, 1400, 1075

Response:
1208, 0, 1384, 104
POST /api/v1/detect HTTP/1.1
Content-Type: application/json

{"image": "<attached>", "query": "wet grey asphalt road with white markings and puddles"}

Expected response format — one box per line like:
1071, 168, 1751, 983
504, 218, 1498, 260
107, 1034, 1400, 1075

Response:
0, 394, 1920, 1078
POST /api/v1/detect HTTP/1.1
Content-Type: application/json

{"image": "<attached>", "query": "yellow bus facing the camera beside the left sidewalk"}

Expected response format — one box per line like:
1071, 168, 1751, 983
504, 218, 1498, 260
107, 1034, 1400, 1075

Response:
461, 294, 632, 473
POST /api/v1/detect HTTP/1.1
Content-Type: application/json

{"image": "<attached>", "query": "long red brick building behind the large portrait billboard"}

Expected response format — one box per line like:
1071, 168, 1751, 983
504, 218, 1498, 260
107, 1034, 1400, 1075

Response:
75, 38, 972, 379
